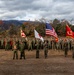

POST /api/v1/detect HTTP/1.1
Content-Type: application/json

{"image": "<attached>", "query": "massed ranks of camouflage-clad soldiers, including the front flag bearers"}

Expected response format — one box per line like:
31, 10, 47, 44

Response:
0, 38, 74, 59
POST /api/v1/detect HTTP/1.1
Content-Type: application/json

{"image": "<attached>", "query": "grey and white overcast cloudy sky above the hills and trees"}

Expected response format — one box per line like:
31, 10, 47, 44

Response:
0, 0, 74, 20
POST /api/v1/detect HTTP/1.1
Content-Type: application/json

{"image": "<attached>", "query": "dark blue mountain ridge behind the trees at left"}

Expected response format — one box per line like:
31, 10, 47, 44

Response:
0, 20, 28, 30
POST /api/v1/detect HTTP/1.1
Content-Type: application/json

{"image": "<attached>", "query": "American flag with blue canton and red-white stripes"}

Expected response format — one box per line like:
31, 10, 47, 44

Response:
46, 23, 57, 38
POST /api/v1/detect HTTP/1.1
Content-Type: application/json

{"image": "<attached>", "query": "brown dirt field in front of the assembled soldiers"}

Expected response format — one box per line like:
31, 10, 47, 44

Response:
0, 50, 74, 75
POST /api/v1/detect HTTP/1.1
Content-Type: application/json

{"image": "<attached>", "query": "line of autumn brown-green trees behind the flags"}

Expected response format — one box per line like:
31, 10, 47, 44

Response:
0, 19, 74, 37
